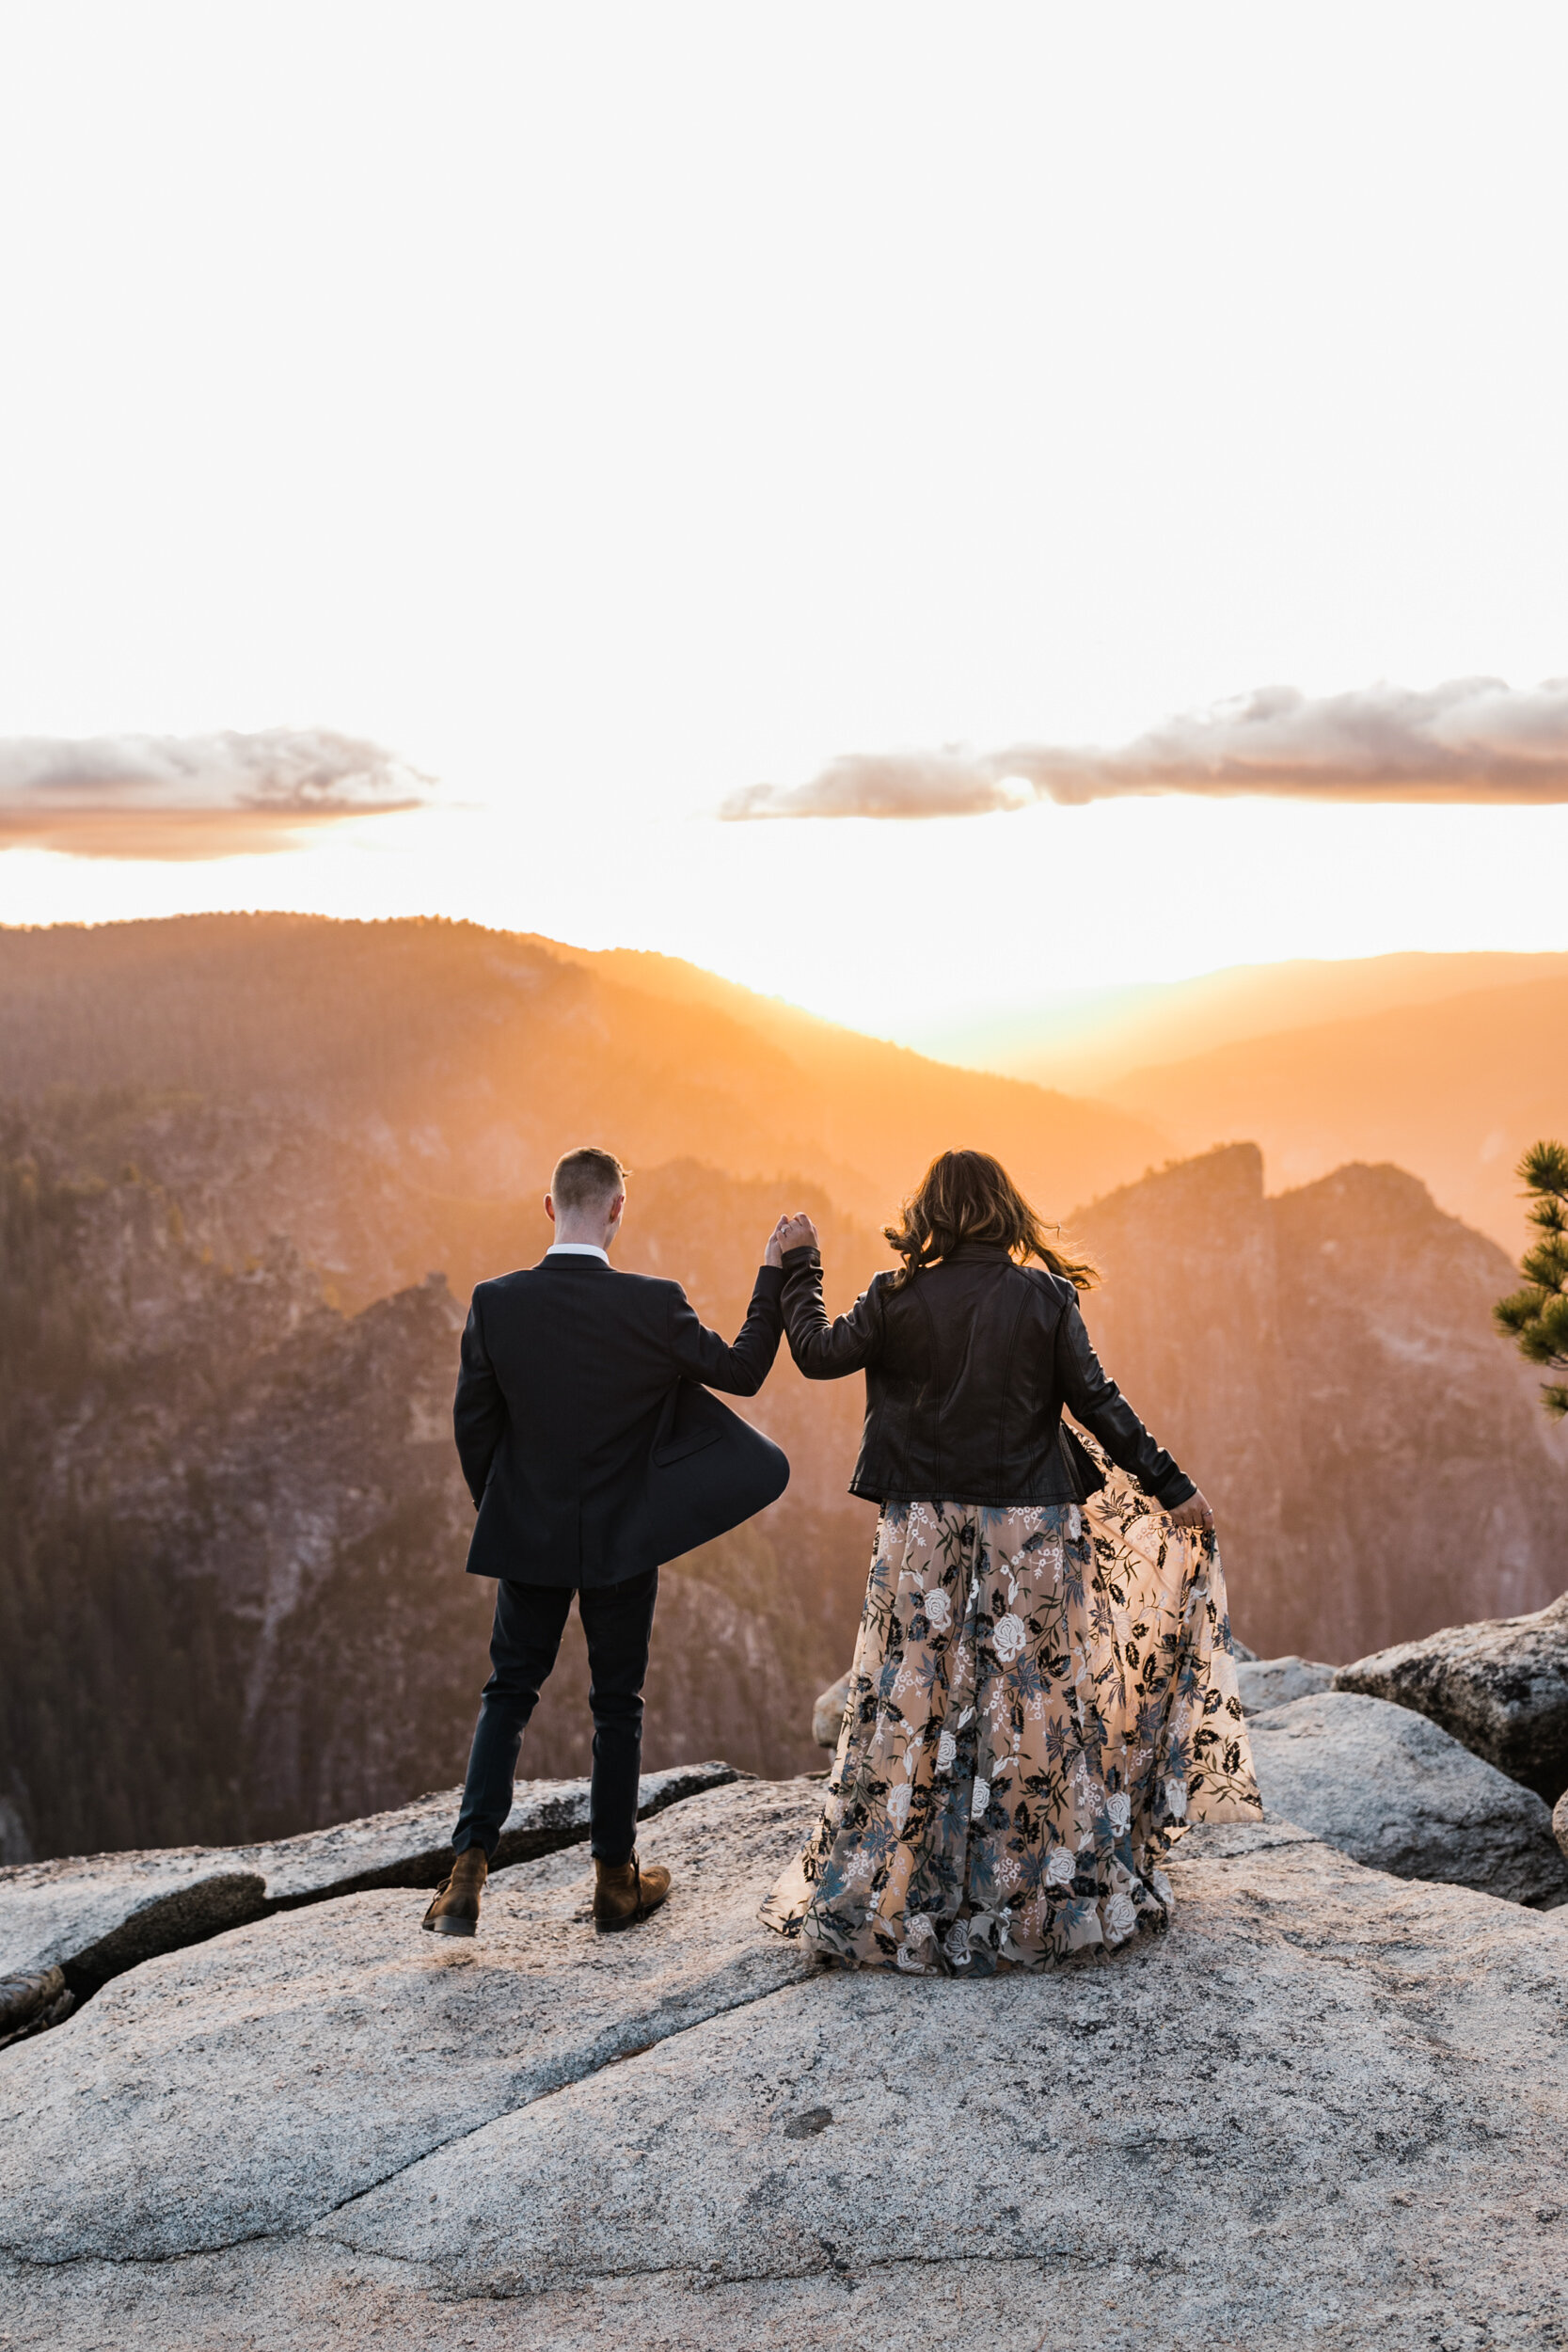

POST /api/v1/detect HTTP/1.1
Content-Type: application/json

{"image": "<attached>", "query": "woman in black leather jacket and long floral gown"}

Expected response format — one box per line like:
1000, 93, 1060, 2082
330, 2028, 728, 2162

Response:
762, 1152, 1262, 1976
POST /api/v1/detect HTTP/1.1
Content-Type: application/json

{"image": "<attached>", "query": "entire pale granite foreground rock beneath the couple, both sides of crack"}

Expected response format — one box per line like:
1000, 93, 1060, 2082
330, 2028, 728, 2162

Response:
0, 1783, 1568, 2352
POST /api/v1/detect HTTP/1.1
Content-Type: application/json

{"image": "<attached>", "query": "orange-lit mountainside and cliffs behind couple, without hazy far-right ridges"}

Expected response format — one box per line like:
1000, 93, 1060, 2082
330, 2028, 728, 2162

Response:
0, 917, 1568, 1858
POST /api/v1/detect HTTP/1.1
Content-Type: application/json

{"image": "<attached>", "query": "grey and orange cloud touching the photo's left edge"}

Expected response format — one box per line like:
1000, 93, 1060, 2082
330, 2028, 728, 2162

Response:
0, 727, 433, 859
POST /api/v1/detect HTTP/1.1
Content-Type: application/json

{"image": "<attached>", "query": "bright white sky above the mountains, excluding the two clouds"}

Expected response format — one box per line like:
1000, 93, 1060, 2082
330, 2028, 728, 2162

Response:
0, 0, 1568, 1038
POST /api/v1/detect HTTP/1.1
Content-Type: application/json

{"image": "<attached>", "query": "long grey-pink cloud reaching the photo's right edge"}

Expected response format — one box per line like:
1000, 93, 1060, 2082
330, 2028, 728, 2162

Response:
720, 677, 1568, 818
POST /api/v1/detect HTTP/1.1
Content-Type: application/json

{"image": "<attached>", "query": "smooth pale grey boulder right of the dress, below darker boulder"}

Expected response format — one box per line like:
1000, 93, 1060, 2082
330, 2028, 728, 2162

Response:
1248, 1692, 1568, 1908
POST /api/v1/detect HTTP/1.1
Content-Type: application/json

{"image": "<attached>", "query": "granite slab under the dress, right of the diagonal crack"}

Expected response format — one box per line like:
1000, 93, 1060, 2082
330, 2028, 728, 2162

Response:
312, 1830, 1568, 2347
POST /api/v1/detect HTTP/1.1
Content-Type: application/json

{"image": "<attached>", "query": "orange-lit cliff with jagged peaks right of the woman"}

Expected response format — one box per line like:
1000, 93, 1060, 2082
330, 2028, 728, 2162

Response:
1077, 1143, 1568, 1663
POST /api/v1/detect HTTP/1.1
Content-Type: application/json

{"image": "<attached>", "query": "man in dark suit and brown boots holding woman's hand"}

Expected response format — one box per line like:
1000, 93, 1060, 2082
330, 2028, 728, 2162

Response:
423, 1148, 790, 1936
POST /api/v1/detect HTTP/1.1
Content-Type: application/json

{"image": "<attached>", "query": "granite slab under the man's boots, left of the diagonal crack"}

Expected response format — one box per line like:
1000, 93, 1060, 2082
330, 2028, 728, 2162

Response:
0, 1783, 820, 2263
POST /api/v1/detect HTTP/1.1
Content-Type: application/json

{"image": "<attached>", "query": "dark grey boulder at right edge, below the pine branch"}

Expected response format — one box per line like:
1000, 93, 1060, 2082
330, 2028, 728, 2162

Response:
1333, 1593, 1568, 1804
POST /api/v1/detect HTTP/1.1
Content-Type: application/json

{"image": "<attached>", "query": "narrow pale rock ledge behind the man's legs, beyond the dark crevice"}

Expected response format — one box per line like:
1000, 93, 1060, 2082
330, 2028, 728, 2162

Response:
0, 1764, 736, 2004
